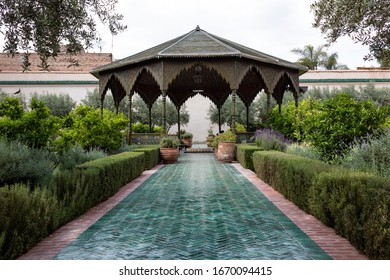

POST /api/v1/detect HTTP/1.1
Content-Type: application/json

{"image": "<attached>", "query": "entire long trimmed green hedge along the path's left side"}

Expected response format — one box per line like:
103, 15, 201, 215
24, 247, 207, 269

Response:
0, 152, 145, 259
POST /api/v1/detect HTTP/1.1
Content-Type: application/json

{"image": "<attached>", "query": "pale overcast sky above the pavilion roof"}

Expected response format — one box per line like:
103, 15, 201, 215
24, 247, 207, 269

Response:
91, 0, 377, 69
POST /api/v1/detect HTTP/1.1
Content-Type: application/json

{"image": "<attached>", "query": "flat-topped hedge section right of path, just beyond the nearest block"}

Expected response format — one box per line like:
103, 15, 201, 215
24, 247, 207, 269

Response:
253, 151, 332, 211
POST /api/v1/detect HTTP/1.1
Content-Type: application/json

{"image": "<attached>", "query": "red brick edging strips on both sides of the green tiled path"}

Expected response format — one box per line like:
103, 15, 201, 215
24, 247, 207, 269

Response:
20, 155, 366, 259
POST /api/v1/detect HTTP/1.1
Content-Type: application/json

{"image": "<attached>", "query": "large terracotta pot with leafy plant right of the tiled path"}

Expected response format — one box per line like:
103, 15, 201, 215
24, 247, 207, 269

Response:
213, 130, 237, 162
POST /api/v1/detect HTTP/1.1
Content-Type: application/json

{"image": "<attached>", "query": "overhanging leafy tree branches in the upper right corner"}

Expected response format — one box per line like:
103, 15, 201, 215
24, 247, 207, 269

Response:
311, 0, 390, 60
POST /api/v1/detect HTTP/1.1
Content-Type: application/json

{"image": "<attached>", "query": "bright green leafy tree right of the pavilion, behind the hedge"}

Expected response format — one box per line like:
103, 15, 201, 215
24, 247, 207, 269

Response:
271, 94, 387, 161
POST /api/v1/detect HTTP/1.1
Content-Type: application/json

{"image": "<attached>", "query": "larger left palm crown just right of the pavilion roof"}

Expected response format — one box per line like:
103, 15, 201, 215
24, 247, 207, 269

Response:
291, 45, 327, 70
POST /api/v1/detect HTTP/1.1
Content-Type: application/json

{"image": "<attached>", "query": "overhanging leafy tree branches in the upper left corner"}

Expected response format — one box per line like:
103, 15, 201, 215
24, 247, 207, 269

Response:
0, 0, 126, 70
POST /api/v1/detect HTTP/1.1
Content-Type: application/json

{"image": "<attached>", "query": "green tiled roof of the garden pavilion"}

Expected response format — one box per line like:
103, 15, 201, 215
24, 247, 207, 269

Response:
91, 26, 307, 77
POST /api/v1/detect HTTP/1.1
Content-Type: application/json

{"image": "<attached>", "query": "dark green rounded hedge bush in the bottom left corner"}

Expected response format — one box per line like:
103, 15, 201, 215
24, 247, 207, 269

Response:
0, 184, 61, 259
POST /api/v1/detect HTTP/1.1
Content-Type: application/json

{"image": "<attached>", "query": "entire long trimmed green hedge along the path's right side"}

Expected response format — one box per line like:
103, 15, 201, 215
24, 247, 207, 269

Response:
253, 151, 390, 259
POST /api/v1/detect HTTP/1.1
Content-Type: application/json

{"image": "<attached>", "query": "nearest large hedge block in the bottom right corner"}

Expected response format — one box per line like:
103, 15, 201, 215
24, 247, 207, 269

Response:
309, 169, 390, 259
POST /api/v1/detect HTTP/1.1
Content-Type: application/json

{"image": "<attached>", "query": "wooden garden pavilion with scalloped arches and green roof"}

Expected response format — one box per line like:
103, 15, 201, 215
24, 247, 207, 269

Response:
91, 26, 308, 143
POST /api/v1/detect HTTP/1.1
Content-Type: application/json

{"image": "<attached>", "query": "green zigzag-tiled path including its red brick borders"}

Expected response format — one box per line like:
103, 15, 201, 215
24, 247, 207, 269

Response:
21, 154, 365, 259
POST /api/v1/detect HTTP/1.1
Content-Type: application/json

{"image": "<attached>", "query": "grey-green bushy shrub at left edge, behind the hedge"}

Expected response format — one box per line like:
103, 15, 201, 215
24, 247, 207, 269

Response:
0, 139, 54, 186
